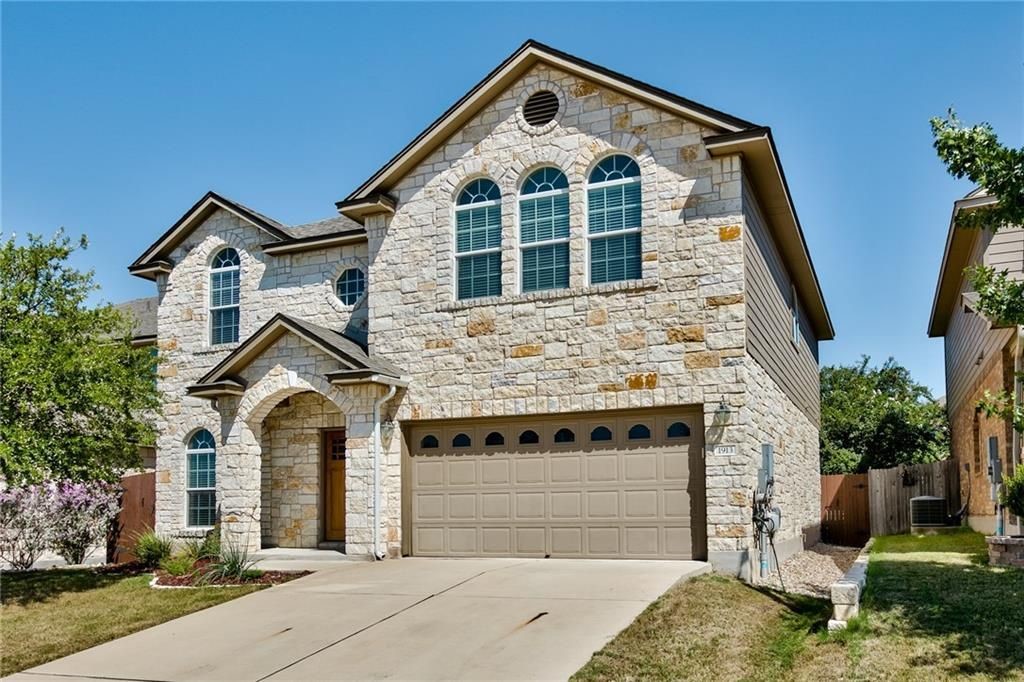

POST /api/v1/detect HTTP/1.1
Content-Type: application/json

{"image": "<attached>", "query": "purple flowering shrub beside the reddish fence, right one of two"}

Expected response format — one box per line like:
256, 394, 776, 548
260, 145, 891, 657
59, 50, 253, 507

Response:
47, 480, 121, 565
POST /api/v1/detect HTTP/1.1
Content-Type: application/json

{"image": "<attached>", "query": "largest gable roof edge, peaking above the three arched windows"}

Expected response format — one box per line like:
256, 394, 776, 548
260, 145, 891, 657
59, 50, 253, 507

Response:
338, 40, 757, 210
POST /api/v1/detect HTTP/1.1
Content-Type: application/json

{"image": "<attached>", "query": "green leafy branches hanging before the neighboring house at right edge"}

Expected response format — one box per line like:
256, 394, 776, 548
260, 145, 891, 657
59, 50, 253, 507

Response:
931, 110, 1024, 433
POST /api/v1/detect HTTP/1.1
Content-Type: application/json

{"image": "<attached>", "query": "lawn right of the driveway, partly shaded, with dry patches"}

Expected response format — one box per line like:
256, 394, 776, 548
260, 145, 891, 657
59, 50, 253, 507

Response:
575, 530, 1024, 682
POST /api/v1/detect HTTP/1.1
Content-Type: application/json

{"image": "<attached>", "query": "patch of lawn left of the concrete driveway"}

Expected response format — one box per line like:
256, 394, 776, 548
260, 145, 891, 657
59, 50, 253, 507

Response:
0, 568, 259, 675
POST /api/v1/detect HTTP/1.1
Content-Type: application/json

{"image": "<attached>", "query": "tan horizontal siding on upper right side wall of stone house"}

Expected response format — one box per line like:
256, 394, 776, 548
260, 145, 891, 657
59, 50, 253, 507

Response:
743, 175, 820, 424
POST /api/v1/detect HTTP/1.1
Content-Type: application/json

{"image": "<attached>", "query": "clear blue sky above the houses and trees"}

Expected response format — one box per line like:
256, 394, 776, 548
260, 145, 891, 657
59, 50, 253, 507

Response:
0, 2, 1024, 394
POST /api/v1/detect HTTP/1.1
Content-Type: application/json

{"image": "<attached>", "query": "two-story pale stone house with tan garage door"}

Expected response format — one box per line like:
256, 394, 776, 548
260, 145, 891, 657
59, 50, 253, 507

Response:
130, 41, 834, 574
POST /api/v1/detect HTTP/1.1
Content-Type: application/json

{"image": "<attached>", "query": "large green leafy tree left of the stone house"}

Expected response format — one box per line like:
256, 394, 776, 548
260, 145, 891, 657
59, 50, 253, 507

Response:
0, 231, 158, 485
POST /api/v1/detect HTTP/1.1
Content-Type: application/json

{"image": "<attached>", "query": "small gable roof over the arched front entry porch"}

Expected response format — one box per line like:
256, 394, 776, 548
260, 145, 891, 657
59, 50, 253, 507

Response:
187, 312, 402, 397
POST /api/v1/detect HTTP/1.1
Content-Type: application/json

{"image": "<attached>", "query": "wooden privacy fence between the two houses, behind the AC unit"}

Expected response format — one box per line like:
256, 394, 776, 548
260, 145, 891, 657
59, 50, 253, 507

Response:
821, 459, 961, 547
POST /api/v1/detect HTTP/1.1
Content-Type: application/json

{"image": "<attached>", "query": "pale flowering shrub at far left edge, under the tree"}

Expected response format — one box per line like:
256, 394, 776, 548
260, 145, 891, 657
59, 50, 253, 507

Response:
0, 485, 53, 570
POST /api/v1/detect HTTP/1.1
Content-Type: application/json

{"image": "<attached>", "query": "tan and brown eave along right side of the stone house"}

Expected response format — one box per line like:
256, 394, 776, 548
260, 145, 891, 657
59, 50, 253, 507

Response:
705, 127, 836, 341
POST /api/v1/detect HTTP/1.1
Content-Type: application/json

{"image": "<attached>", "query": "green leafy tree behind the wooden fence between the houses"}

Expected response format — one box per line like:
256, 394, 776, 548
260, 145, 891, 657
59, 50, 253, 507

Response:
820, 356, 949, 474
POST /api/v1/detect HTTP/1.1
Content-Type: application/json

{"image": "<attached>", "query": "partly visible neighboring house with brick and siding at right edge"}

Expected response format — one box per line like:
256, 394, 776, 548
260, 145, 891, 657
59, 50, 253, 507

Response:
928, 189, 1024, 534
